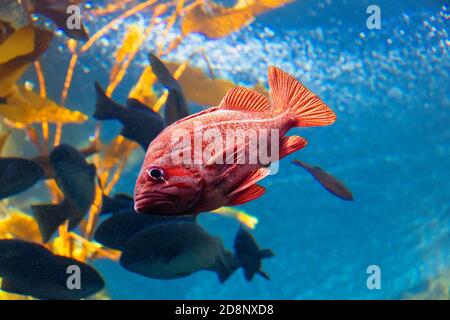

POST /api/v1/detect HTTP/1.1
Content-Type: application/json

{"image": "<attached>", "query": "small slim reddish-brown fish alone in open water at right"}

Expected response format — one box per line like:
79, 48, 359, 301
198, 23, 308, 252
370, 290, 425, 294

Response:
292, 160, 353, 201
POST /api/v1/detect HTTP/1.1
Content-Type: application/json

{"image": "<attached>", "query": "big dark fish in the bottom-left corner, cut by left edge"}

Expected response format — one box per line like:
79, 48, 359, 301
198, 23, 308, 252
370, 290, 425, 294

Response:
0, 239, 105, 300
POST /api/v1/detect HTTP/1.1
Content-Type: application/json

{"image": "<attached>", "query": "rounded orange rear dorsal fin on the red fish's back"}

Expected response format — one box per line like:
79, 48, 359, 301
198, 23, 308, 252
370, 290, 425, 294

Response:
219, 87, 272, 112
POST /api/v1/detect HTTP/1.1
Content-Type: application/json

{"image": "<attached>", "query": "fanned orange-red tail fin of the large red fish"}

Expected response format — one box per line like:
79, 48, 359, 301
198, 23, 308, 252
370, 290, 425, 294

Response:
268, 67, 336, 127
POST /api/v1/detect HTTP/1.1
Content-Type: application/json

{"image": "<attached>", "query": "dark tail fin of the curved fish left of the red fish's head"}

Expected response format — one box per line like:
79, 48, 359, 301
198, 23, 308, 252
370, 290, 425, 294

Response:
31, 201, 69, 242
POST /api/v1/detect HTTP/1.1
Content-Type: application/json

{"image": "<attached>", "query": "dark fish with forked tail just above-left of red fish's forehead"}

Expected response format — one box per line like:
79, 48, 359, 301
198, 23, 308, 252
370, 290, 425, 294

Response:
94, 83, 164, 150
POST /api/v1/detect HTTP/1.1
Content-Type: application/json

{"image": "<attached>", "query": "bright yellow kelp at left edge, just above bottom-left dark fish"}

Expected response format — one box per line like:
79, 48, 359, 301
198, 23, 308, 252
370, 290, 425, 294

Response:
0, 210, 42, 242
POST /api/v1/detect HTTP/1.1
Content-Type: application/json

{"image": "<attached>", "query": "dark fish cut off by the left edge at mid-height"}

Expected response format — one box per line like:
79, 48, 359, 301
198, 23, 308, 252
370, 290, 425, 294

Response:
0, 158, 45, 200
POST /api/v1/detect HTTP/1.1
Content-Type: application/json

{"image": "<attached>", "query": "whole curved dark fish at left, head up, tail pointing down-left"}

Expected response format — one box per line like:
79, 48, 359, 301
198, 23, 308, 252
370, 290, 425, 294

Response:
31, 145, 96, 242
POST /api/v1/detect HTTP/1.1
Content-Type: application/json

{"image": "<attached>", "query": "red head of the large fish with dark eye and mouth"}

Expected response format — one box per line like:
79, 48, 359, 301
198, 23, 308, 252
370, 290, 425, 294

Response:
134, 163, 203, 215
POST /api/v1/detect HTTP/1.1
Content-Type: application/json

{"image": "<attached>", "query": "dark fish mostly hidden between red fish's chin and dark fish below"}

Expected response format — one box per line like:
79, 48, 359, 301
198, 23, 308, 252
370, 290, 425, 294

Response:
94, 209, 196, 250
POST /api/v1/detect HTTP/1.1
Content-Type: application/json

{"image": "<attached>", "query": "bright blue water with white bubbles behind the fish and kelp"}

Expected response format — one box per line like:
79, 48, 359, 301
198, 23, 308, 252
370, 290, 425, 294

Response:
3, 0, 450, 299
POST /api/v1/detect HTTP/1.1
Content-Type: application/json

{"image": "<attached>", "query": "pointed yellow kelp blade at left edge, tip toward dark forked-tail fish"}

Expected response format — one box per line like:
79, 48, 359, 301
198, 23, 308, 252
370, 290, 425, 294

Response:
0, 86, 88, 128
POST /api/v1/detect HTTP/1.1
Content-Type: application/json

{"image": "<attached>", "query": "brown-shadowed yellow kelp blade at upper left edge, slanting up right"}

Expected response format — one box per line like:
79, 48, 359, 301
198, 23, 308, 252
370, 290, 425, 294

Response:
0, 26, 53, 97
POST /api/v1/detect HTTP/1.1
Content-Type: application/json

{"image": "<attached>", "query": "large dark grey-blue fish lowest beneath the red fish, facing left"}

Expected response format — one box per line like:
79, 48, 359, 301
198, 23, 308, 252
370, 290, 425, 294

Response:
120, 223, 238, 282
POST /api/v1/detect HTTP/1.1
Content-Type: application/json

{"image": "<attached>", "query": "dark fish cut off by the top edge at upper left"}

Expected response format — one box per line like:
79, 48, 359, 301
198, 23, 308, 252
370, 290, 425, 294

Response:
23, 0, 89, 41
